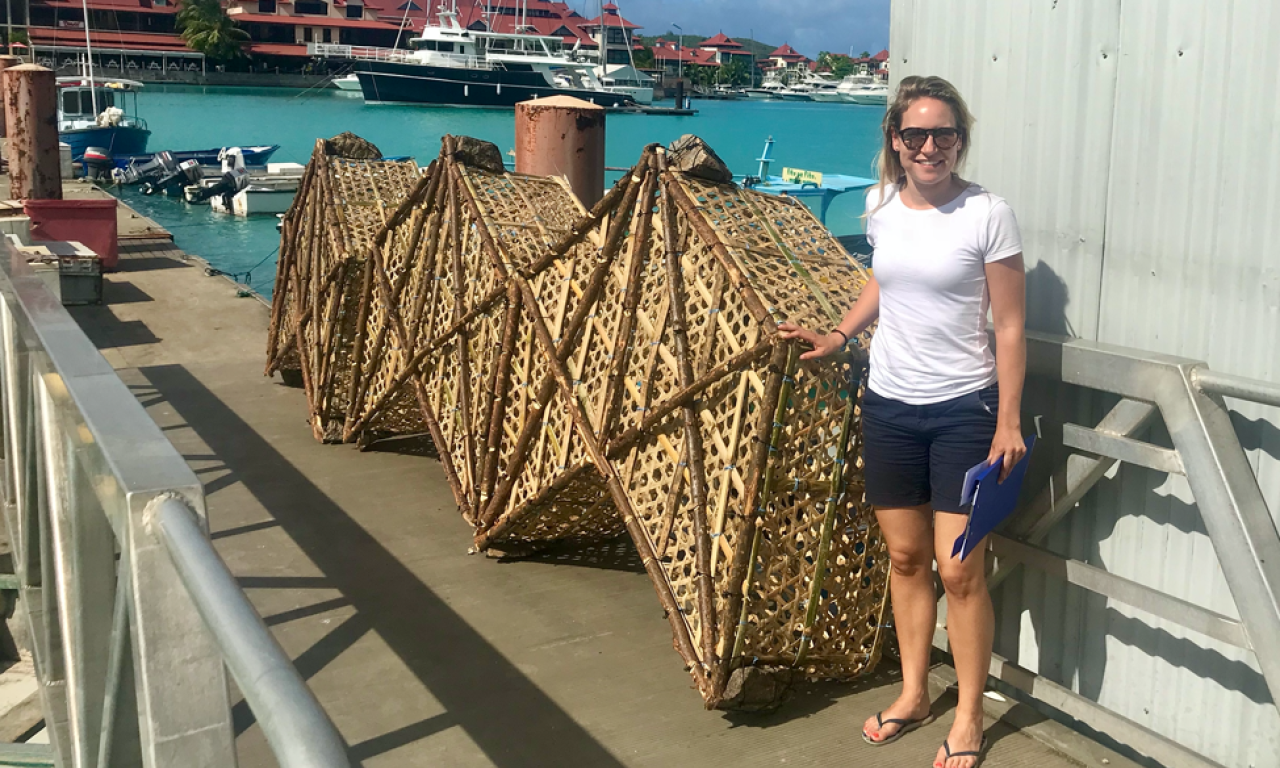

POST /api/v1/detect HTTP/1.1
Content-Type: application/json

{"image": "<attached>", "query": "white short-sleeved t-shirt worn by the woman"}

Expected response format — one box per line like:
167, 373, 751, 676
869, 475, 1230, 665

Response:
867, 184, 1023, 404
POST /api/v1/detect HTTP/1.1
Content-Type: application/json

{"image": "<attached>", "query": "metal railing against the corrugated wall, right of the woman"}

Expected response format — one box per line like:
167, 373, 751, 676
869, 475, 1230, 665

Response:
934, 333, 1280, 767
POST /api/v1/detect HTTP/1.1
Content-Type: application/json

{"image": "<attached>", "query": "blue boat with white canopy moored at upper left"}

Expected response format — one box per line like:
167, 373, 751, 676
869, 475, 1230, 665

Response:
58, 77, 151, 161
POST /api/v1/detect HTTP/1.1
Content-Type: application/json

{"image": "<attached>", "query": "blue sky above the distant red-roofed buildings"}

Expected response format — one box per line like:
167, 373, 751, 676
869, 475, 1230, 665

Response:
581, 0, 890, 59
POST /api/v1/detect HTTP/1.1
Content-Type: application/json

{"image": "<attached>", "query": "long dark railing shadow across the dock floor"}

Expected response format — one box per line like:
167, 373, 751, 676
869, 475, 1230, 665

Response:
140, 365, 621, 768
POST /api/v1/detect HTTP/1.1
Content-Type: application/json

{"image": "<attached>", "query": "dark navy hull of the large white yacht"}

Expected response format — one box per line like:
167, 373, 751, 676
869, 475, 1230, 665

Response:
356, 61, 635, 109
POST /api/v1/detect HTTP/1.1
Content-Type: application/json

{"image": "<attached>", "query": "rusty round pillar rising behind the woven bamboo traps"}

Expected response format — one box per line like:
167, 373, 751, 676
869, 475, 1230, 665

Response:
516, 96, 604, 209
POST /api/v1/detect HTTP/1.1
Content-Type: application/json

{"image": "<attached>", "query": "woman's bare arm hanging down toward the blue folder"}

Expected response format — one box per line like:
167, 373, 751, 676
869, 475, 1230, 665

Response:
986, 253, 1027, 481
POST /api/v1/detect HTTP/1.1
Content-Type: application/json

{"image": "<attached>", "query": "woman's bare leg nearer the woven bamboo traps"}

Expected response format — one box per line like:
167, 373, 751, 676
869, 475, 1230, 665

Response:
863, 504, 938, 741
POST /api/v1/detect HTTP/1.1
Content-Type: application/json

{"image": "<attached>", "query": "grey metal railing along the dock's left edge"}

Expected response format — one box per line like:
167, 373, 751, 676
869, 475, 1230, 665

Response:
0, 242, 349, 768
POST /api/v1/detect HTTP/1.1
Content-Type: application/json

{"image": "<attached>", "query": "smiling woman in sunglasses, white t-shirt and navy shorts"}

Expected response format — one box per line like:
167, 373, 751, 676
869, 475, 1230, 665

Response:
781, 77, 1027, 768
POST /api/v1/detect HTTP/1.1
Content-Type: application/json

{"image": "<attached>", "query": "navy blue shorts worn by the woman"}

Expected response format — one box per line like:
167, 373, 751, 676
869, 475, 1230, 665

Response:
863, 384, 1000, 515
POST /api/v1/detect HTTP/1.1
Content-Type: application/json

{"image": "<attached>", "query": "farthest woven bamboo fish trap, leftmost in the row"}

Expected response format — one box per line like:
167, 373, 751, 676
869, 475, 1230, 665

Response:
266, 134, 420, 442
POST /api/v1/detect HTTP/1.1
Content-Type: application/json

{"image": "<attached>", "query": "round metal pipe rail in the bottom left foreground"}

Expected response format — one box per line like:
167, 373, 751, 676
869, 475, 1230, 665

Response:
152, 498, 349, 768
